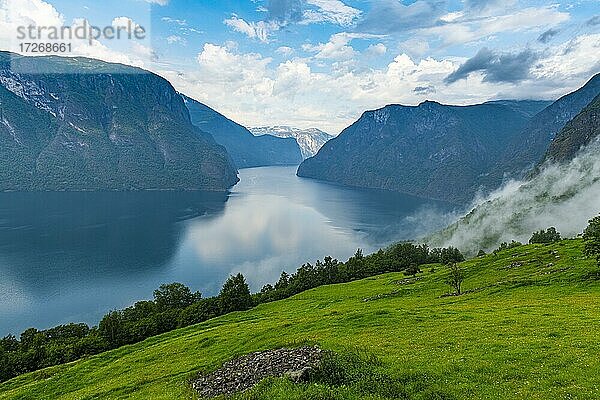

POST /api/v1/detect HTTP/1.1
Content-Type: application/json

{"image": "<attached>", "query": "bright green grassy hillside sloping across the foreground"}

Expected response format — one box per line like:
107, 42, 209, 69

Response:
0, 240, 600, 400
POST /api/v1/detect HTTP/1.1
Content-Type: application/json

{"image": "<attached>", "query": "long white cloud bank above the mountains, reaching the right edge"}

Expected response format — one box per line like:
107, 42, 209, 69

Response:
165, 34, 600, 133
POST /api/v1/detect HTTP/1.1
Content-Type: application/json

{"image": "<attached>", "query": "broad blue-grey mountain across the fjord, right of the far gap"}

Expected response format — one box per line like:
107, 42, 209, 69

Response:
298, 101, 548, 204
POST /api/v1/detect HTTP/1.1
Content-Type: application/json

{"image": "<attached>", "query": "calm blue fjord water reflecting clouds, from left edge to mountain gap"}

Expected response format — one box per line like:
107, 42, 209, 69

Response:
0, 167, 451, 336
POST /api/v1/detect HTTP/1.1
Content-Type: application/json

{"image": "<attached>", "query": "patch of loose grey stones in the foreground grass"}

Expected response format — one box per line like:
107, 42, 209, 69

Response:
192, 347, 324, 398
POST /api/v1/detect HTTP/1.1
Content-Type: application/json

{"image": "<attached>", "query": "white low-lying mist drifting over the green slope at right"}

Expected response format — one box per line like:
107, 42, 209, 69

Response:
424, 142, 600, 255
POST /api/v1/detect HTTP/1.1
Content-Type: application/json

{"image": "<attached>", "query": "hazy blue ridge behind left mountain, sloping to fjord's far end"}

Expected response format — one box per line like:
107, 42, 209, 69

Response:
182, 95, 302, 168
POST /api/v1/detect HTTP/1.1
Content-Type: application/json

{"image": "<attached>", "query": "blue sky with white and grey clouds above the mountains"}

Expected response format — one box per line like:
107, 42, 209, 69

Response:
0, 0, 600, 134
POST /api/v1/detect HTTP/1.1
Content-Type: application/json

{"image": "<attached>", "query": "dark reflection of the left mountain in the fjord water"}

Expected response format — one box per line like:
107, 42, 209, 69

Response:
0, 192, 227, 292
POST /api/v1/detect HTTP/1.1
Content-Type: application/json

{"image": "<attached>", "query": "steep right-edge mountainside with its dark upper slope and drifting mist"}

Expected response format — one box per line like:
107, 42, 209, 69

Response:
426, 96, 600, 255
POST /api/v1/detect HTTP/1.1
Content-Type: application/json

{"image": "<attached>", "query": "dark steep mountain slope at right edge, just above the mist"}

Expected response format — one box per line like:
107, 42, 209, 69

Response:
541, 95, 600, 165
